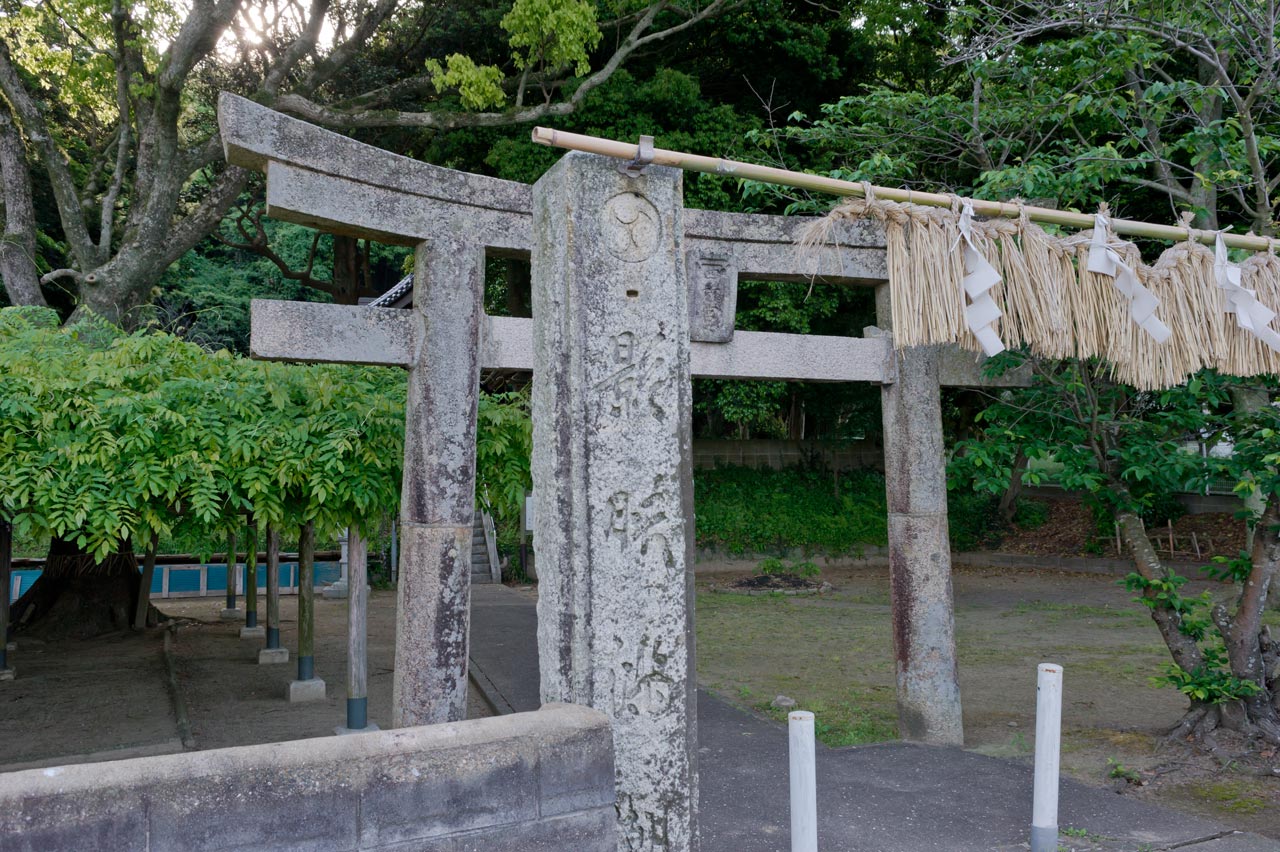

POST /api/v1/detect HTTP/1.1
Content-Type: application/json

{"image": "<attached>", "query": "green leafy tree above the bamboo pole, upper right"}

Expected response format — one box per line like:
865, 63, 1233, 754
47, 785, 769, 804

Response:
777, 0, 1280, 233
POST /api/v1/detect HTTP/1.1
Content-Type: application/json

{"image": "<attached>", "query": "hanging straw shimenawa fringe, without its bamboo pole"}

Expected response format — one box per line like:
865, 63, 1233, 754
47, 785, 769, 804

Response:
800, 197, 1280, 390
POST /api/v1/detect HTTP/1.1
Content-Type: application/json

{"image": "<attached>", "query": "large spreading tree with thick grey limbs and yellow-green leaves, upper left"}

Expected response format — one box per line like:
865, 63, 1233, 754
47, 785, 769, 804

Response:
0, 0, 728, 324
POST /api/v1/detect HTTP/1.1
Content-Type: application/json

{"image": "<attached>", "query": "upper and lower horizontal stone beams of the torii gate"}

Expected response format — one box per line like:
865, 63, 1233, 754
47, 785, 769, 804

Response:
218, 92, 1025, 386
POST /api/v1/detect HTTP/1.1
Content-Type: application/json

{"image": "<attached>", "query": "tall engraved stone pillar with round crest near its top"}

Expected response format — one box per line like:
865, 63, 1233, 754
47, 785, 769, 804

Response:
532, 154, 698, 852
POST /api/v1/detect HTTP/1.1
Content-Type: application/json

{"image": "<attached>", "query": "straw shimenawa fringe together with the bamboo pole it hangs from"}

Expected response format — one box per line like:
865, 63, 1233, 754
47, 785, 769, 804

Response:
519, 127, 1280, 389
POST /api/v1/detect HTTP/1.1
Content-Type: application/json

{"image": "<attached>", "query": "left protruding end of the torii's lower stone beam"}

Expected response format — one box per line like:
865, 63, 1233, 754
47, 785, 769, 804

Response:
248, 299, 416, 367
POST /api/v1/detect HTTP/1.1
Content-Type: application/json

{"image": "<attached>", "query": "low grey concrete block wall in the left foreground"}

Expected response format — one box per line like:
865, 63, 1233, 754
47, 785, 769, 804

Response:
0, 704, 617, 852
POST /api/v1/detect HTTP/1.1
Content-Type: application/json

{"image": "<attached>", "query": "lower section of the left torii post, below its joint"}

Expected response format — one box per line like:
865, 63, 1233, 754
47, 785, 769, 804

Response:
392, 521, 471, 727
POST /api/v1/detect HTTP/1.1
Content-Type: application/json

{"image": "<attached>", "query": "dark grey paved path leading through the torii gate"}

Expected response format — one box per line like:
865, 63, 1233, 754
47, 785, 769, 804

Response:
471, 586, 1280, 852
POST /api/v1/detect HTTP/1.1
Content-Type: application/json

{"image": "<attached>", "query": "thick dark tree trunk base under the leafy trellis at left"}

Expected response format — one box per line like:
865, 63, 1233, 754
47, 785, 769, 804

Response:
9, 539, 159, 640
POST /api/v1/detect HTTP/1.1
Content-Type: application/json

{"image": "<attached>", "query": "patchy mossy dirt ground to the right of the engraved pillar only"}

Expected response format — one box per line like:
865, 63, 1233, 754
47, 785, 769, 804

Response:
698, 563, 1280, 838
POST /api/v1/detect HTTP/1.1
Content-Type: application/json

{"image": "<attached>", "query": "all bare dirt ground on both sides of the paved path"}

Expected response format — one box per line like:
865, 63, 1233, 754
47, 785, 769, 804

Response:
0, 563, 1280, 838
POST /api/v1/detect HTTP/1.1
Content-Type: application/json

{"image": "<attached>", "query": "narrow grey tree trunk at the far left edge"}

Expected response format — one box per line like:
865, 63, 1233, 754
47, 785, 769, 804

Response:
0, 99, 45, 306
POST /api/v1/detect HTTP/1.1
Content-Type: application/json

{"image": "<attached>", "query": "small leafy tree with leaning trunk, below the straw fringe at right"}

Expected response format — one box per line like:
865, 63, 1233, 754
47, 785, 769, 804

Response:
951, 356, 1280, 742
